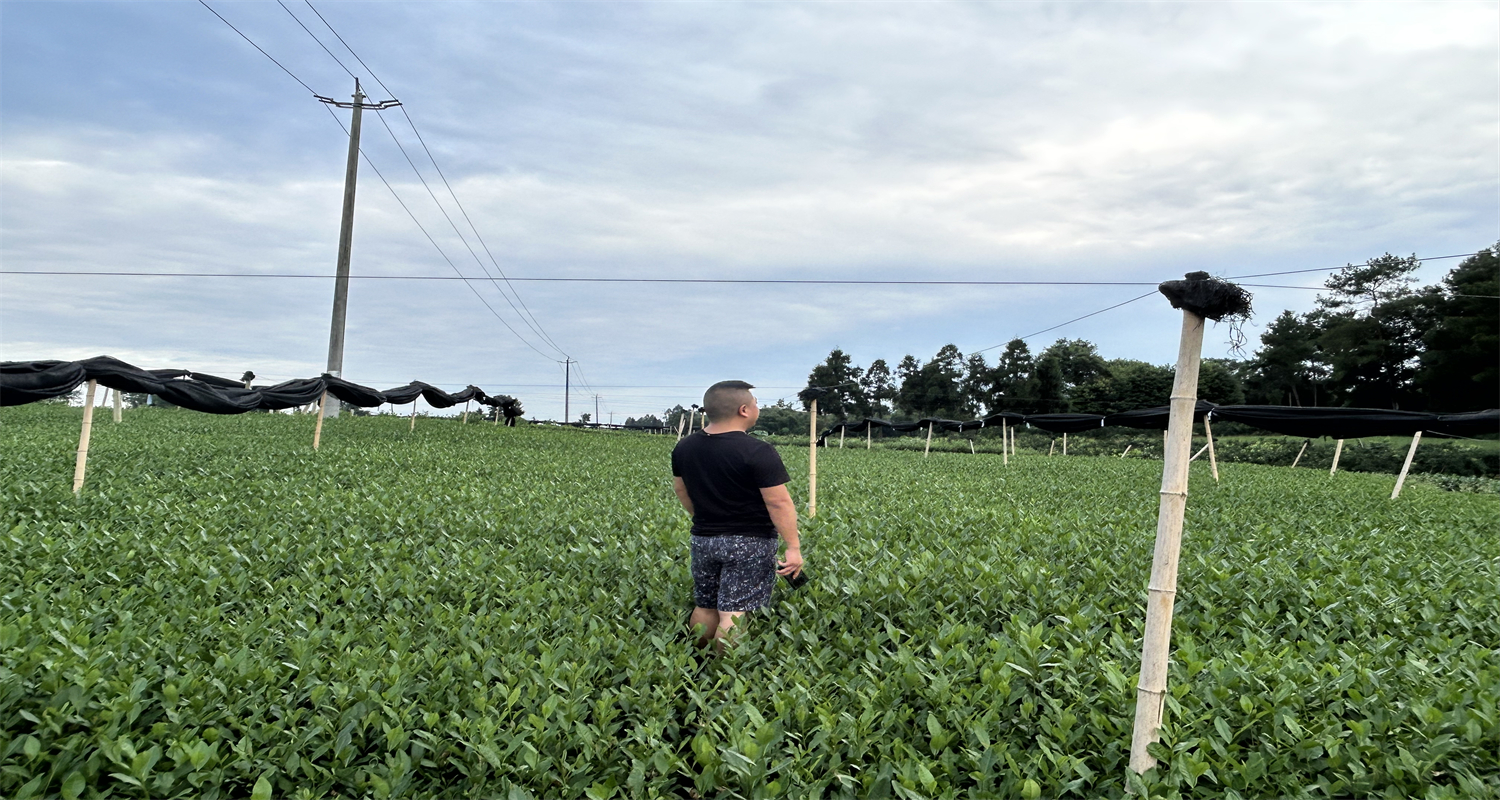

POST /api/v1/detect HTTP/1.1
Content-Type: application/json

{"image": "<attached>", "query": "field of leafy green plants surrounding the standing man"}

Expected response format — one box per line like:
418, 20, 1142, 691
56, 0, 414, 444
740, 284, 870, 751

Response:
0, 404, 1500, 800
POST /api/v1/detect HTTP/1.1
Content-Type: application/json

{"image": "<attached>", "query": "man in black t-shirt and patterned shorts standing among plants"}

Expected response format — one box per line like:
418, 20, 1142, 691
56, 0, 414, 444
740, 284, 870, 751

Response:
672, 381, 803, 650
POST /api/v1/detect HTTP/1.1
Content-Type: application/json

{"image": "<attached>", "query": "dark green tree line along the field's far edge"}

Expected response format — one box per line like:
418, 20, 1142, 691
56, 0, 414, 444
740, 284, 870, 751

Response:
807, 245, 1500, 419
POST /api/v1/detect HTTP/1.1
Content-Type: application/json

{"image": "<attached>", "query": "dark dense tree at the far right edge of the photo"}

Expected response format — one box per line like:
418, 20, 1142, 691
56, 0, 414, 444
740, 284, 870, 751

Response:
1416, 243, 1500, 411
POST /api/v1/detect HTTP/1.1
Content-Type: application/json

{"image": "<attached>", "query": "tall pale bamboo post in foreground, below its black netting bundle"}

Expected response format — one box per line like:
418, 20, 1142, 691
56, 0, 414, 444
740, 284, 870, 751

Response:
1130, 311, 1203, 773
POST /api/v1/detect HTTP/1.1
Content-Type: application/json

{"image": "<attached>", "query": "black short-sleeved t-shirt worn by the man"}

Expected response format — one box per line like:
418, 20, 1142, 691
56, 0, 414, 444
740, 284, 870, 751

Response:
672, 431, 791, 539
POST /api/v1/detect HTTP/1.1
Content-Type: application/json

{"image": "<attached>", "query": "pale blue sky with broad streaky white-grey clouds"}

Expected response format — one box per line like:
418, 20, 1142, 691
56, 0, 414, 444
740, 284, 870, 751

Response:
0, 0, 1500, 422
